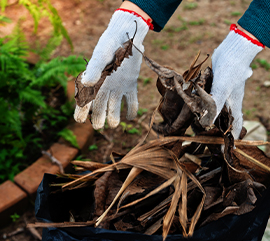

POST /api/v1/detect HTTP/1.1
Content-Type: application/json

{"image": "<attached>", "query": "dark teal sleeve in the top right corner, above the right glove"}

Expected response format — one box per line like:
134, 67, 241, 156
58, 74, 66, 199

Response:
238, 0, 270, 48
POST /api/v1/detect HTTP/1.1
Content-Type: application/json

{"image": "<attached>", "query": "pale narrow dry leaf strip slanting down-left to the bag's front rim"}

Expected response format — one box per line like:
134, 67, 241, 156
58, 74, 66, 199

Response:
95, 167, 143, 227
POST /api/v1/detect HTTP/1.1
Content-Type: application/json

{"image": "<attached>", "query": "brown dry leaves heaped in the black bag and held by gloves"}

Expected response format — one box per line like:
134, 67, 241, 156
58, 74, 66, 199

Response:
29, 30, 270, 239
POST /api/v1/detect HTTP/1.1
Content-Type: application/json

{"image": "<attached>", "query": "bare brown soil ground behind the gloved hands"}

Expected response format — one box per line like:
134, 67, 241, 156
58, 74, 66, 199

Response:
0, 0, 270, 241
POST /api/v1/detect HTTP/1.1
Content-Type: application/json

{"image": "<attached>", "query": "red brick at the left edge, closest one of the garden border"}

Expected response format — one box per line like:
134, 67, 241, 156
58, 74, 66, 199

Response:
0, 181, 28, 227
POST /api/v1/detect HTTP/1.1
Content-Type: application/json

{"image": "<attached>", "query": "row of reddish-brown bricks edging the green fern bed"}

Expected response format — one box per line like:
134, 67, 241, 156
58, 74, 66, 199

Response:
0, 81, 94, 228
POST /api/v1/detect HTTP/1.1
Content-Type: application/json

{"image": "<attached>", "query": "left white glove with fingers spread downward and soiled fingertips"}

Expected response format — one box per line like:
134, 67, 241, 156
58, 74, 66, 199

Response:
74, 9, 152, 129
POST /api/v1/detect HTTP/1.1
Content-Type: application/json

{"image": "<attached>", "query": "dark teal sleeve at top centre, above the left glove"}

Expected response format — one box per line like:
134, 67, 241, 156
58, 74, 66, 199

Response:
129, 0, 182, 32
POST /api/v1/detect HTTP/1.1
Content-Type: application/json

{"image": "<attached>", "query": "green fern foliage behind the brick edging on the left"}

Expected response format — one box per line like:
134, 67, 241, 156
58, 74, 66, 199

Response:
0, 0, 85, 183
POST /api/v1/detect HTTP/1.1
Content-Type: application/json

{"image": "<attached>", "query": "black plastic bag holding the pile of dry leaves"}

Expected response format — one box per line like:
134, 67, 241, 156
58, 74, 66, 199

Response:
35, 174, 270, 241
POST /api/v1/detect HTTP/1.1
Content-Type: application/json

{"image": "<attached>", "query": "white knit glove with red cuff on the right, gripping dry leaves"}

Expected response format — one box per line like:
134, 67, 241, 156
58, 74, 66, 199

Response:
211, 25, 264, 139
